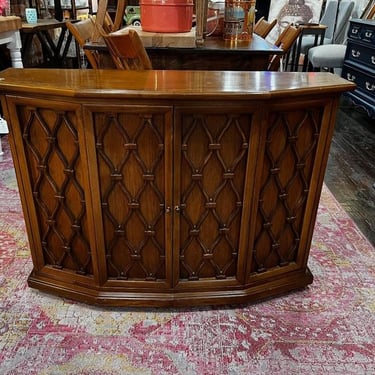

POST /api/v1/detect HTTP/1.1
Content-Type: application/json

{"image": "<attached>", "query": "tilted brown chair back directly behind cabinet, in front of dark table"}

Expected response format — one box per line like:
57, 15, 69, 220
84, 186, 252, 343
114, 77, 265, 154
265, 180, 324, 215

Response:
102, 29, 152, 70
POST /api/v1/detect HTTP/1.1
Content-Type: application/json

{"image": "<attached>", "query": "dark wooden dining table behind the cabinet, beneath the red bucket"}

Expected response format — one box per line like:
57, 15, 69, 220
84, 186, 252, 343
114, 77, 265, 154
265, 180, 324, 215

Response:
84, 29, 283, 71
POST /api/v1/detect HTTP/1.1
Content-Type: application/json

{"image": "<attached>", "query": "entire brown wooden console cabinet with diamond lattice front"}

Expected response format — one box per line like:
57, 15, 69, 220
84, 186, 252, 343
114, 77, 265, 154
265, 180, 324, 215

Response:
0, 69, 355, 306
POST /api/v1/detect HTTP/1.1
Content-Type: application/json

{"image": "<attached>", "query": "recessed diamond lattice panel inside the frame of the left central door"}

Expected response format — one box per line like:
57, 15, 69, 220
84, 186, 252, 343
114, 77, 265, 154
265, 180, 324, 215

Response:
95, 113, 165, 281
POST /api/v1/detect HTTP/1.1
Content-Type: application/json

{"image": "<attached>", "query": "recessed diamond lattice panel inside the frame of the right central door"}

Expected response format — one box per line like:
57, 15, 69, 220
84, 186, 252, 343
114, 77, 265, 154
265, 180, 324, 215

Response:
180, 114, 251, 280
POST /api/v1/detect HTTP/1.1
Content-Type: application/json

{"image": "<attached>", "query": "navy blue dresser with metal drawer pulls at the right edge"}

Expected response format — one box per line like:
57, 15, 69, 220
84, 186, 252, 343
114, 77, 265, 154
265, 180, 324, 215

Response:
342, 20, 375, 117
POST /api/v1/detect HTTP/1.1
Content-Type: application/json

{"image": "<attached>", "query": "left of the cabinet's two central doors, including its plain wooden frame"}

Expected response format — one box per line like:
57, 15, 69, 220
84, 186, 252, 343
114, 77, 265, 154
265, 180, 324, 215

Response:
85, 105, 173, 289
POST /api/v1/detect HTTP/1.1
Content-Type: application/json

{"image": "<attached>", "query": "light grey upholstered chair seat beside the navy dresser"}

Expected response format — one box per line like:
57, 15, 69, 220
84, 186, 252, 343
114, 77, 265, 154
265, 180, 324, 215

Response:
308, 44, 346, 68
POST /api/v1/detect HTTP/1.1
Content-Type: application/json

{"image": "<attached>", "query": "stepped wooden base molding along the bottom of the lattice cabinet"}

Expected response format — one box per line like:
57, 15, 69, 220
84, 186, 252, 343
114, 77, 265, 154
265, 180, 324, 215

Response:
28, 268, 313, 307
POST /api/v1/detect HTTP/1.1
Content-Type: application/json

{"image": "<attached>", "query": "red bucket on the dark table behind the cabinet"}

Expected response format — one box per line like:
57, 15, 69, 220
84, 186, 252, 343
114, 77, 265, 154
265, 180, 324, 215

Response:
139, 0, 193, 33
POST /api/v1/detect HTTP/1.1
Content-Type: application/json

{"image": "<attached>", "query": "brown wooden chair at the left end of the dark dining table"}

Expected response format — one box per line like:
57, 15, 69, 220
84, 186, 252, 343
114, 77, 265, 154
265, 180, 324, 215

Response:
66, 19, 100, 69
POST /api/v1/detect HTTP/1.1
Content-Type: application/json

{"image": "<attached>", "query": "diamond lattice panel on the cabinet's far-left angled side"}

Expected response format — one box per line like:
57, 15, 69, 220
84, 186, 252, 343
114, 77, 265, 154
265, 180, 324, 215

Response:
20, 107, 92, 274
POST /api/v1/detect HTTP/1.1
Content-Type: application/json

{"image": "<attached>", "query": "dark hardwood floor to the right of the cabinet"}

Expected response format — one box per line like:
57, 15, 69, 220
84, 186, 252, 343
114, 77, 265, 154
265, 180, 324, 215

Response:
325, 96, 375, 246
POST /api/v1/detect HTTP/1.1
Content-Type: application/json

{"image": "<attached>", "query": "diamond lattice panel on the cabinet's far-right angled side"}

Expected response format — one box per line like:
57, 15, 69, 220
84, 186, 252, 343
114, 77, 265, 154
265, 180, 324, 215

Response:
252, 109, 322, 272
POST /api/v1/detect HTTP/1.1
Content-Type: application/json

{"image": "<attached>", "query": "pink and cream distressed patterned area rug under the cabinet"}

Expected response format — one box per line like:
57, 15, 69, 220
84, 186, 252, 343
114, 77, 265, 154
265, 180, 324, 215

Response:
0, 138, 375, 375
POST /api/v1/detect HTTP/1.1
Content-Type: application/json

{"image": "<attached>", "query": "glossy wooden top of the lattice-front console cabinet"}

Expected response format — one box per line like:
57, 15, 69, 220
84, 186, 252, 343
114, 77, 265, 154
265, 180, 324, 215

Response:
0, 68, 355, 99
